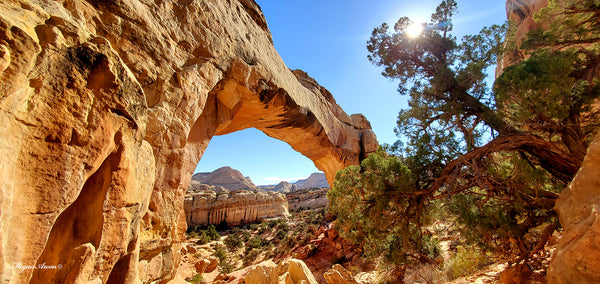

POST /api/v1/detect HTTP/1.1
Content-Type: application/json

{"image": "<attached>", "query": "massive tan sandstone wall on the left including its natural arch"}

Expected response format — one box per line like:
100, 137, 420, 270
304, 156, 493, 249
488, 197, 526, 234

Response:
0, 0, 377, 283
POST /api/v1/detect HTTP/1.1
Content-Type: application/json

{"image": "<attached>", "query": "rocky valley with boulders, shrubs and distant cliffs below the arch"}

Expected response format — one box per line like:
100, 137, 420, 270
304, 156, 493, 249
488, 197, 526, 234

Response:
177, 167, 561, 284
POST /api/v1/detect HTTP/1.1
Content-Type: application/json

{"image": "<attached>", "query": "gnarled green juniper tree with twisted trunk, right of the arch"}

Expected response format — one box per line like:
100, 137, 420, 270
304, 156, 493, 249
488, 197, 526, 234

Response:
328, 0, 600, 272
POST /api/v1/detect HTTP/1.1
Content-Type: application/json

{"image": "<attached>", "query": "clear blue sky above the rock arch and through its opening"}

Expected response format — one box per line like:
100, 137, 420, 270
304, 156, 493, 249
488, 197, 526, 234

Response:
196, 0, 506, 185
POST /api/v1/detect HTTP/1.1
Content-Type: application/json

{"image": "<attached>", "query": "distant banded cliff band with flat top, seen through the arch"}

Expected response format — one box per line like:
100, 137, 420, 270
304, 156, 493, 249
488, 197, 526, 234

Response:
184, 190, 290, 226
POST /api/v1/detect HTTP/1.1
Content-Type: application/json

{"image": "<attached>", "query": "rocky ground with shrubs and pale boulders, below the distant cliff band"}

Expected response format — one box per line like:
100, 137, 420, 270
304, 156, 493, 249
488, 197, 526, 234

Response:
172, 206, 560, 284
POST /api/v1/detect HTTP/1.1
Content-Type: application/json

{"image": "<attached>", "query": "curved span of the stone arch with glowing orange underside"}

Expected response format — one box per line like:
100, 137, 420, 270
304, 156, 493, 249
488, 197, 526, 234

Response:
185, 61, 378, 184
